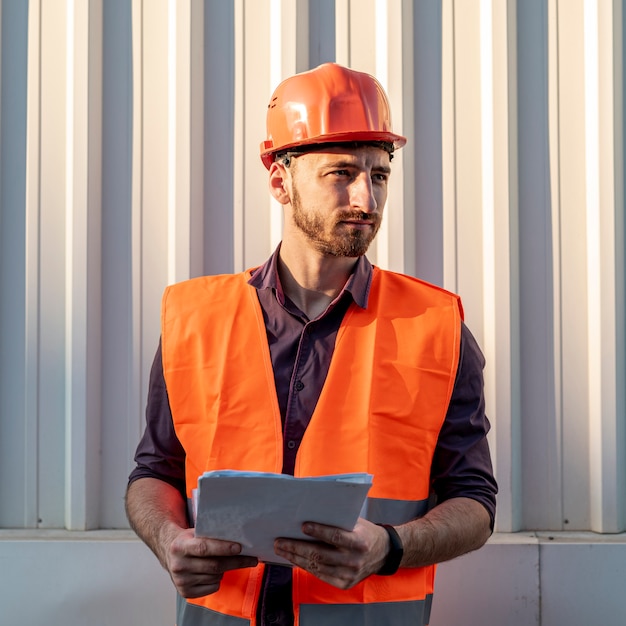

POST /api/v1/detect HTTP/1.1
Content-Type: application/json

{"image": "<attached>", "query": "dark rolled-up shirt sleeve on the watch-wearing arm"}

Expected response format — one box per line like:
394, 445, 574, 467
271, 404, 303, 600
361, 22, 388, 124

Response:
431, 324, 498, 529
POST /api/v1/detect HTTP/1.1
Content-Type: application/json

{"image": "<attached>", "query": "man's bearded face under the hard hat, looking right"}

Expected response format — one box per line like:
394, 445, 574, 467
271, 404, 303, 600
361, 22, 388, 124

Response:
290, 146, 390, 257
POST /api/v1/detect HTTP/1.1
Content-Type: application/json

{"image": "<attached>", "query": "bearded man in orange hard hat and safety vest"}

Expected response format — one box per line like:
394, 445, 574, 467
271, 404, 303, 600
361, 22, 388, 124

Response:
127, 63, 496, 626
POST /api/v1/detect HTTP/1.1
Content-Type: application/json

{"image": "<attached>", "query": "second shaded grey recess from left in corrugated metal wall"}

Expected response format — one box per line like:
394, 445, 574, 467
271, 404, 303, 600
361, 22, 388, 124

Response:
97, 0, 137, 528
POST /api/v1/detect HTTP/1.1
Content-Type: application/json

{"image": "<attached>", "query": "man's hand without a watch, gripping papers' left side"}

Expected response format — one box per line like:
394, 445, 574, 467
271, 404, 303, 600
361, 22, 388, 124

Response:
165, 528, 258, 598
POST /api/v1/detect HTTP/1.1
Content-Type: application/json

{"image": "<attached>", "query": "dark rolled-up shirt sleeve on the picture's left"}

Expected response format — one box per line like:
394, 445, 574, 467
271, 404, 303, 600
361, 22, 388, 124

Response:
128, 342, 186, 496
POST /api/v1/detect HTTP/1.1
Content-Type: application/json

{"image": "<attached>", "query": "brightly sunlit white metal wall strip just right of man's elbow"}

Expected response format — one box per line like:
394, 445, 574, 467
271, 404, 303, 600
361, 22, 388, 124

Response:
481, 0, 522, 532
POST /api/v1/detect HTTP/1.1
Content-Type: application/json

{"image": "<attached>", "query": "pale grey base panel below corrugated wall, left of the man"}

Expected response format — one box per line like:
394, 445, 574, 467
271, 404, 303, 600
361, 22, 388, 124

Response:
0, 531, 176, 626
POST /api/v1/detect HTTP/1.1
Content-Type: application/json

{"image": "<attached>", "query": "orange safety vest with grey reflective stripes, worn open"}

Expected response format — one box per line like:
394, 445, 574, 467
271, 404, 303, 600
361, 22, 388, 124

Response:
162, 267, 462, 626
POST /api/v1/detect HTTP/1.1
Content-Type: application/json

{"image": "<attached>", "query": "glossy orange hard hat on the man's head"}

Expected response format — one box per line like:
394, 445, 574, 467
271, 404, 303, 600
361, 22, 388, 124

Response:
261, 63, 406, 169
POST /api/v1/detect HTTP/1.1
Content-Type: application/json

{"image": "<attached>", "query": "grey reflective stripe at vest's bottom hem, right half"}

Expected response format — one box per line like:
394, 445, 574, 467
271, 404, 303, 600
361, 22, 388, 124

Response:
300, 596, 432, 626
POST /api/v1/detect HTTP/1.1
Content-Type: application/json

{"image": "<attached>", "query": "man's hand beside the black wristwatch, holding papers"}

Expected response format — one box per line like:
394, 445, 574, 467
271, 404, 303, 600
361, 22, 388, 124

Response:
274, 518, 389, 589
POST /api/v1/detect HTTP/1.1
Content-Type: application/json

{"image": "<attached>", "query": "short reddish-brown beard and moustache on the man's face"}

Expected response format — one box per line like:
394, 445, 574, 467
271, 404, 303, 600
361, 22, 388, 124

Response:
291, 186, 381, 257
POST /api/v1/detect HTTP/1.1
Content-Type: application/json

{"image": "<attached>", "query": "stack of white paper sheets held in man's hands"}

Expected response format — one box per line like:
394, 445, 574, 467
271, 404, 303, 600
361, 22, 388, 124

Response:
193, 470, 373, 565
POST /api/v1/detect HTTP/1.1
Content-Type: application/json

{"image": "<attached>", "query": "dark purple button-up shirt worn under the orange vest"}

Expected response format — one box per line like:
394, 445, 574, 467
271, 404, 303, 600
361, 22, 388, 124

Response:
129, 250, 497, 626
